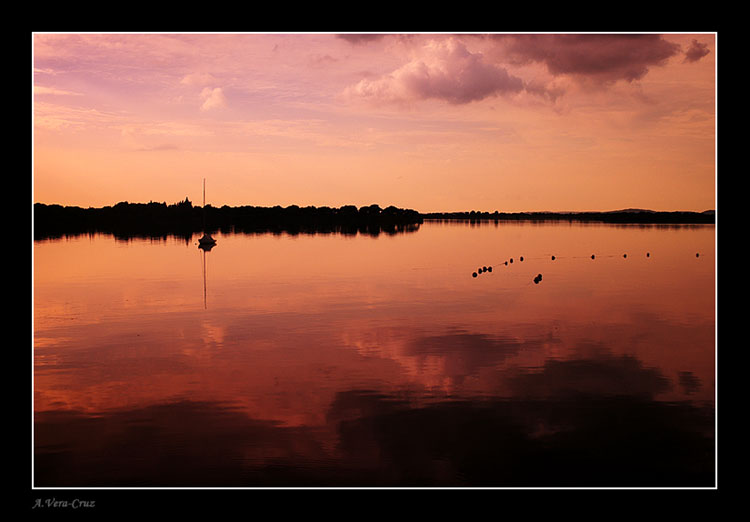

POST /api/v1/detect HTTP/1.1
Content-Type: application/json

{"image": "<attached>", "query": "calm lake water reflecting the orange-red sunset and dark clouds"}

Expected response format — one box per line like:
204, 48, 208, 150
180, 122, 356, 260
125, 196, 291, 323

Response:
33, 217, 716, 487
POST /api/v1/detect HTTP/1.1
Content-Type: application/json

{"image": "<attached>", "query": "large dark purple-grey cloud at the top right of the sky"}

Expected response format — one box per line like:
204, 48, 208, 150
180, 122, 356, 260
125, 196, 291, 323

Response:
495, 34, 680, 83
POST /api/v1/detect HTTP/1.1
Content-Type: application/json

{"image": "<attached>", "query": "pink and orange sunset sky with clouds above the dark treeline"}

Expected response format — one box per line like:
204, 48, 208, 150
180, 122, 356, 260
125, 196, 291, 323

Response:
32, 33, 717, 212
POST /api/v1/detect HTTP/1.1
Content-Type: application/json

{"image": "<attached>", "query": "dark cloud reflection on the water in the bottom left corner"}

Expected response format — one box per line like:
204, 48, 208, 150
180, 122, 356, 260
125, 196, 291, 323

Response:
34, 401, 334, 487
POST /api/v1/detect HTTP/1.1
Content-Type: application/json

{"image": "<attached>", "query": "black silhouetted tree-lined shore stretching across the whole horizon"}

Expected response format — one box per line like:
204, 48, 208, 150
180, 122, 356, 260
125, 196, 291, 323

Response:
32, 198, 716, 239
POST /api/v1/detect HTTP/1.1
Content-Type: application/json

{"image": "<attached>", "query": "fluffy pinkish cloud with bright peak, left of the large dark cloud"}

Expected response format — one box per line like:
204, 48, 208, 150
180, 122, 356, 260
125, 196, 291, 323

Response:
347, 38, 524, 104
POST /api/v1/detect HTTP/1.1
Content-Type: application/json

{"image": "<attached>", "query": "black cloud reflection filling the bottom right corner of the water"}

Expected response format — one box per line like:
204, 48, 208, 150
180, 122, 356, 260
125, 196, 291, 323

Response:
330, 384, 714, 487
